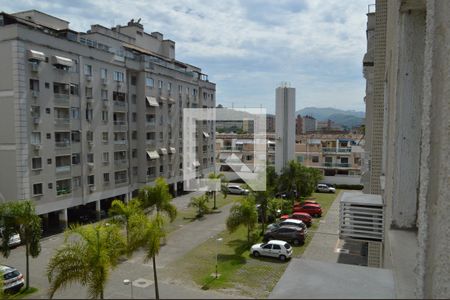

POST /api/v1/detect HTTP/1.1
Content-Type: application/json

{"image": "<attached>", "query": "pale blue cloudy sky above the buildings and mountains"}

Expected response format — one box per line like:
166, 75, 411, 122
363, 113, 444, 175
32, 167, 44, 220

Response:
1, 0, 375, 112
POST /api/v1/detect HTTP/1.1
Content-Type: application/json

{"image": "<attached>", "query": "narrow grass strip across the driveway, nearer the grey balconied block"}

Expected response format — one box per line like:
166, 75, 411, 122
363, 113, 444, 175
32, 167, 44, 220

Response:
165, 194, 242, 234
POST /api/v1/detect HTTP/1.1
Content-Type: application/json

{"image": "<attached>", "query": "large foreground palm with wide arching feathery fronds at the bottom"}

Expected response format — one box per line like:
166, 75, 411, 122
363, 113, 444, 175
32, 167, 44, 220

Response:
47, 224, 126, 299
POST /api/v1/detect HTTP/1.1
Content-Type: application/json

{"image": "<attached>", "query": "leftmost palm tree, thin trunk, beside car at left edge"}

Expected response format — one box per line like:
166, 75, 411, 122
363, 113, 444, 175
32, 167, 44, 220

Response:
0, 200, 41, 289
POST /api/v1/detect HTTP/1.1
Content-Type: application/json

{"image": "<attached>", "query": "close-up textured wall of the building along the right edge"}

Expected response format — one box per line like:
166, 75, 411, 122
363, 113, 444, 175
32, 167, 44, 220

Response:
353, 0, 450, 298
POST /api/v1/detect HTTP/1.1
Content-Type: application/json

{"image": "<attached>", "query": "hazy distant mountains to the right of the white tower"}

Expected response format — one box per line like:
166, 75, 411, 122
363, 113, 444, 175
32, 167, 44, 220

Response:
295, 107, 365, 128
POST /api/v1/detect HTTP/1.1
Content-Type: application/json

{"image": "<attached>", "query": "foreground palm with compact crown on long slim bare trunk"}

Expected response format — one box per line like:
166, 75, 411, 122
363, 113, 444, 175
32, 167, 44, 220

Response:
130, 214, 166, 299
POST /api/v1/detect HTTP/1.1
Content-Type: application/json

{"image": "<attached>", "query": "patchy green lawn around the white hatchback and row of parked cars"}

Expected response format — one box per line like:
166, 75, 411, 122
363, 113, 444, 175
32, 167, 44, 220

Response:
165, 190, 340, 298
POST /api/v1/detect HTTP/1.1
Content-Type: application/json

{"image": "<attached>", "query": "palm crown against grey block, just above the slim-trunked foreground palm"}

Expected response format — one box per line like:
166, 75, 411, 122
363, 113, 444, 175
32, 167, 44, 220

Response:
138, 177, 177, 222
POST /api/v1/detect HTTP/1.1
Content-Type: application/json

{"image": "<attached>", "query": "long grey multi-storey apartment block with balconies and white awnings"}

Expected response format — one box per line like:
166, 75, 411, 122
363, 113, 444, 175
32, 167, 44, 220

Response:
0, 10, 215, 230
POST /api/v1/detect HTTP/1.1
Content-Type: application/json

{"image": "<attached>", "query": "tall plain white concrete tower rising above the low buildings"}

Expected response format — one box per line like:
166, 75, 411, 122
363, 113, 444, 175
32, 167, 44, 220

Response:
275, 84, 295, 173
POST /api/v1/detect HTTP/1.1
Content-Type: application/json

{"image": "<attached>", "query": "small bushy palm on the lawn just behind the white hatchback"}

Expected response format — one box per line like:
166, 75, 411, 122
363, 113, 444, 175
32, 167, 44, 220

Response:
226, 195, 258, 242
